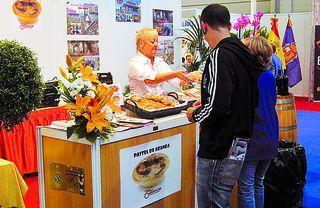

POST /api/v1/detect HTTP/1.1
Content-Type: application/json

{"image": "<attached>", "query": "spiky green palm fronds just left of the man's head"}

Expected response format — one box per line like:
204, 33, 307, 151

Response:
177, 17, 213, 71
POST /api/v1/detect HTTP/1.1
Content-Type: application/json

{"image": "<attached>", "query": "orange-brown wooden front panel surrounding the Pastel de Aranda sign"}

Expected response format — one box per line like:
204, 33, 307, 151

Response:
101, 124, 196, 208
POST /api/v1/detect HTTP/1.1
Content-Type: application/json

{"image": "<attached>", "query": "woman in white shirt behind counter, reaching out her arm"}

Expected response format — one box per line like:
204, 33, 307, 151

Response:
128, 28, 193, 94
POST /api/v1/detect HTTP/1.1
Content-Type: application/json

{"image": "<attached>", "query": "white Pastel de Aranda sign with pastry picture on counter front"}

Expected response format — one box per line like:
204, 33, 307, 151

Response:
120, 134, 181, 208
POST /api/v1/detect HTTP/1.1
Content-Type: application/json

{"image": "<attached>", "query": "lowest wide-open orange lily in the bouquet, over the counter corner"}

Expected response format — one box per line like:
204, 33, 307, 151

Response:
83, 107, 110, 133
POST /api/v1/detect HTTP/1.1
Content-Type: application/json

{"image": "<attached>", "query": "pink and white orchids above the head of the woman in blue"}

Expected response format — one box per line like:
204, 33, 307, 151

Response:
233, 11, 268, 39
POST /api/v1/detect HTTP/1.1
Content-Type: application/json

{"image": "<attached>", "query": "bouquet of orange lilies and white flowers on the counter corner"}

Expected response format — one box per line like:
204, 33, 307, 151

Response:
58, 54, 120, 142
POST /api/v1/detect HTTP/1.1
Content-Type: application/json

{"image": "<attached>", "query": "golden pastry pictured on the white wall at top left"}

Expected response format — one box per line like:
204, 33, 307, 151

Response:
12, 0, 41, 24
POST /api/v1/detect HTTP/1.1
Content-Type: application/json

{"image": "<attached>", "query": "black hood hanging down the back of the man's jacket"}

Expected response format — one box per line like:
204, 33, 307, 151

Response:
216, 37, 264, 82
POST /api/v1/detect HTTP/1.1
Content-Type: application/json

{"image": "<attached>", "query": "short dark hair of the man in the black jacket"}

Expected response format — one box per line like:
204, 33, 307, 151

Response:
200, 4, 231, 29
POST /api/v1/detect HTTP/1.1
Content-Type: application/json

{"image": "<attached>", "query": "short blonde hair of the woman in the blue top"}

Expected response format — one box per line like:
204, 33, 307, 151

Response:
242, 36, 273, 69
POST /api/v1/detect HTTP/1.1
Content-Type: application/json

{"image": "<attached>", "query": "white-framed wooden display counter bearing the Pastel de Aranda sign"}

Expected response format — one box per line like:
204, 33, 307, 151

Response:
37, 113, 197, 208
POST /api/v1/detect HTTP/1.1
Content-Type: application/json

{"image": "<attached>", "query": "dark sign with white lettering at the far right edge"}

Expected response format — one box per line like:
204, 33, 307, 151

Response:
313, 25, 320, 101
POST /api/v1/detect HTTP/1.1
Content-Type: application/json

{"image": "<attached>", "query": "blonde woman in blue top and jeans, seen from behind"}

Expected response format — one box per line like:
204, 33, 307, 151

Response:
238, 36, 279, 208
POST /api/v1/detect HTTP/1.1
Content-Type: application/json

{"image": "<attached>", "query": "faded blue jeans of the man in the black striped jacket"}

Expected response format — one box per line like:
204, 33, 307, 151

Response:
196, 140, 247, 208
